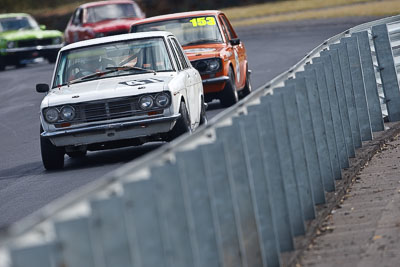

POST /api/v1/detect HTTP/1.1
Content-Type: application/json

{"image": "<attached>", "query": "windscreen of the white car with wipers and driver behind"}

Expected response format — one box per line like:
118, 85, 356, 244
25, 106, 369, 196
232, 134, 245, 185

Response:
53, 37, 173, 88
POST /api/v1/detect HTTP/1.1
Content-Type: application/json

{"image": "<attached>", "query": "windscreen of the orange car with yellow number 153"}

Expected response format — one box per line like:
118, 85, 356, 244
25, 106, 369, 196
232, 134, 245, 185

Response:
132, 16, 223, 46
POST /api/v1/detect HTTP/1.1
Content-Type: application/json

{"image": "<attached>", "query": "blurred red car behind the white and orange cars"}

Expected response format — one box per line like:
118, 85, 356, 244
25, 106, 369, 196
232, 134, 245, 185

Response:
64, 0, 145, 44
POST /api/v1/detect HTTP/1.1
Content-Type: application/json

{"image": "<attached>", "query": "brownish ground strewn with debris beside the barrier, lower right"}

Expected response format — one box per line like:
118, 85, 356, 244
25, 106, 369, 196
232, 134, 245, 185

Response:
296, 124, 400, 267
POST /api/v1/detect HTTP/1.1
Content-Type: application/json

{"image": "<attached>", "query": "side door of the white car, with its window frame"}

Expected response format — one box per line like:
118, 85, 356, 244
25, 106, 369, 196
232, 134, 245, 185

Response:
171, 37, 200, 127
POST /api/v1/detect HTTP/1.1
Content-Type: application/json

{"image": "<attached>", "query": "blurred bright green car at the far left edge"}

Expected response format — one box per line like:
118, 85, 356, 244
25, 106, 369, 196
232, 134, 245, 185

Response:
0, 13, 63, 70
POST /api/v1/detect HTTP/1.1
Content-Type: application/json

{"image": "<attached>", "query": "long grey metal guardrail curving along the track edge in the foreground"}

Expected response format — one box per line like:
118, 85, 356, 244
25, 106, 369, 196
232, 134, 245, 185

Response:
0, 16, 400, 267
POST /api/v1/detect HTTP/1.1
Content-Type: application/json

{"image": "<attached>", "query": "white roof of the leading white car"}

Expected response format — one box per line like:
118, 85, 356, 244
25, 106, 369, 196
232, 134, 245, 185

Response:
61, 31, 173, 51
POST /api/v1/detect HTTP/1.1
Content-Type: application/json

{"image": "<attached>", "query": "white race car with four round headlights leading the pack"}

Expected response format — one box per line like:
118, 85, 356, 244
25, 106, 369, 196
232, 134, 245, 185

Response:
36, 32, 206, 169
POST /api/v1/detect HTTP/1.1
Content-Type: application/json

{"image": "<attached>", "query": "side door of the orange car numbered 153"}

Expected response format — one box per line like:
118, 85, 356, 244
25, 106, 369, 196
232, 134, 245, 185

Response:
220, 14, 246, 88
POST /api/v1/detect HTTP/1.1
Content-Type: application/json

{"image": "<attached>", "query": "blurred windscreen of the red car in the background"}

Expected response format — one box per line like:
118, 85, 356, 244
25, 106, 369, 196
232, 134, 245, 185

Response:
86, 4, 138, 23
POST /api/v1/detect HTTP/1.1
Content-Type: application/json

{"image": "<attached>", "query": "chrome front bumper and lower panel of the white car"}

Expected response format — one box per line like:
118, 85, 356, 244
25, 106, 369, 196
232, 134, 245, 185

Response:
41, 114, 181, 146
